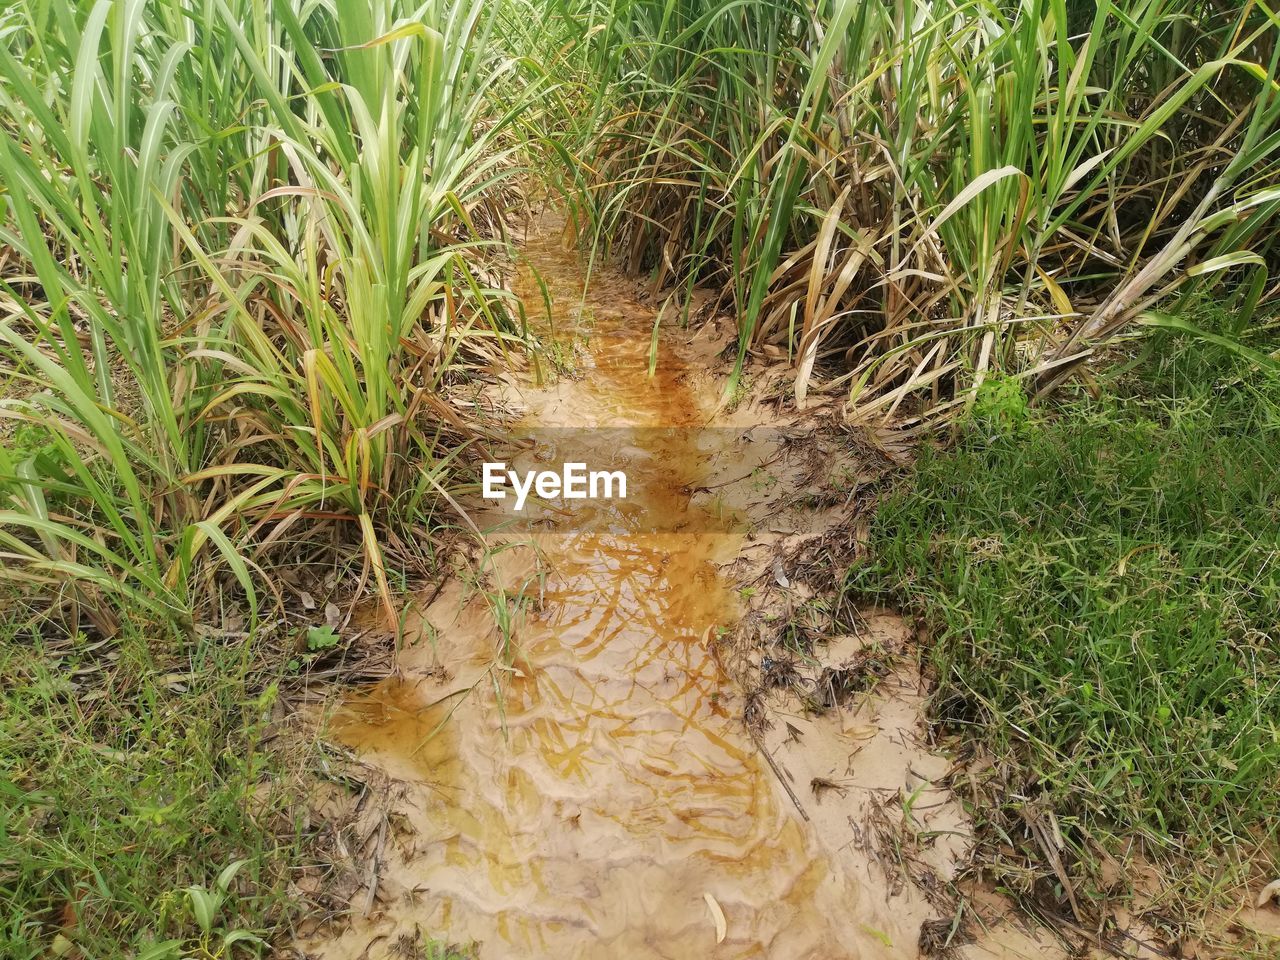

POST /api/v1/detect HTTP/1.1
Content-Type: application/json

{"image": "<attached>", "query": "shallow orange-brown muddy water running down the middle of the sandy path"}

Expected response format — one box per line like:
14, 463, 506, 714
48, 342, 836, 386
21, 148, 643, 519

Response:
320, 224, 915, 960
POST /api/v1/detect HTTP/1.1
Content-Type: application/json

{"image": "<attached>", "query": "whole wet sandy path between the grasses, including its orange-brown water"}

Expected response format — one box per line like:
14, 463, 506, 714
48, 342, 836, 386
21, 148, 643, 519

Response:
277, 217, 1259, 960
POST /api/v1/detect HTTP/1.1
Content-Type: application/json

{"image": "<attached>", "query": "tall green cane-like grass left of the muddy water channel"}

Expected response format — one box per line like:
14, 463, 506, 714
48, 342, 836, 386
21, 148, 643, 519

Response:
0, 0, 536, 631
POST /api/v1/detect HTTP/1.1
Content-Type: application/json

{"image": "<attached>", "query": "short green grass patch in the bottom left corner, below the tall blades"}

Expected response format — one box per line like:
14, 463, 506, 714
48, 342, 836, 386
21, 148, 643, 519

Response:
0, 619, 300, 960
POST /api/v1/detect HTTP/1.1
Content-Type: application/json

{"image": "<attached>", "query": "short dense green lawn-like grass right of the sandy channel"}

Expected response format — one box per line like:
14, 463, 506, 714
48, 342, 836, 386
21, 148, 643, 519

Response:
850, 323, 1280, 870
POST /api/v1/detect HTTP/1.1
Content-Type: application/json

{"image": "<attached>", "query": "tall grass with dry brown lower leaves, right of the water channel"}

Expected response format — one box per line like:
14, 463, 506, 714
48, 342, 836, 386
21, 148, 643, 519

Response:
524, 0, 1280, 429
